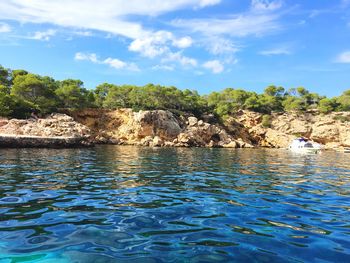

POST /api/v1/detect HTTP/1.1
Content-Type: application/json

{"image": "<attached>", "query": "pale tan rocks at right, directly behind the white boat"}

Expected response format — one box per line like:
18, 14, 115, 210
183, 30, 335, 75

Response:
236, 111, 350, 148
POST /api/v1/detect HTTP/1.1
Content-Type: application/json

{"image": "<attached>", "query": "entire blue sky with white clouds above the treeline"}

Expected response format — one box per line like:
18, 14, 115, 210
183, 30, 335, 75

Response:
0, 0, 350, 96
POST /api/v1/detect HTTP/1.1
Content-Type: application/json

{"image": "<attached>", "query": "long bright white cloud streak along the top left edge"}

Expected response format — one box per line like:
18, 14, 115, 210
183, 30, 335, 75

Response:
0, 0, 220, 39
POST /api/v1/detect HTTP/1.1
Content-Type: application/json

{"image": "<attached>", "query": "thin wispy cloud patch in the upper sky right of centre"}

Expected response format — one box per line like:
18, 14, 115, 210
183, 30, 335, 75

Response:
171, 6, 282, 61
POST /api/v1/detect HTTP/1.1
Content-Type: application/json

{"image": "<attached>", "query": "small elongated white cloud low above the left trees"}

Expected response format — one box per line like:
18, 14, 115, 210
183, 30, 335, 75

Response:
74, 52, 140, 71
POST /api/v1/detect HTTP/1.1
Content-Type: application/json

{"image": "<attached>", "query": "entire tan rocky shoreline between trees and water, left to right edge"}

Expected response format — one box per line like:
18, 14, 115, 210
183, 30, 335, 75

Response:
0, 109, 350, 149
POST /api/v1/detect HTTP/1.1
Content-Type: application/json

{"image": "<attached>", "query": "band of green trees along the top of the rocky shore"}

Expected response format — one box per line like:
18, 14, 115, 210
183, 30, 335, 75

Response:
0, 66, 350, 119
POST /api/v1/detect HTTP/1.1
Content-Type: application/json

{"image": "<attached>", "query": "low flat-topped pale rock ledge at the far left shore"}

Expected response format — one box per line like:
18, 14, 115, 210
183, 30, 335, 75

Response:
0, 114, 91, 147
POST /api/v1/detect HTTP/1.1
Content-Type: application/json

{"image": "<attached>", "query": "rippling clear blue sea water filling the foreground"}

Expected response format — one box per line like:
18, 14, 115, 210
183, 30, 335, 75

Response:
0, 146, 350, 263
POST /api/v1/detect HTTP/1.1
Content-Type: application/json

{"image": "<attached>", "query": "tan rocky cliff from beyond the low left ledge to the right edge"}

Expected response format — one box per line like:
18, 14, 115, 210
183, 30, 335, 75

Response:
71, 109, 350, 148
